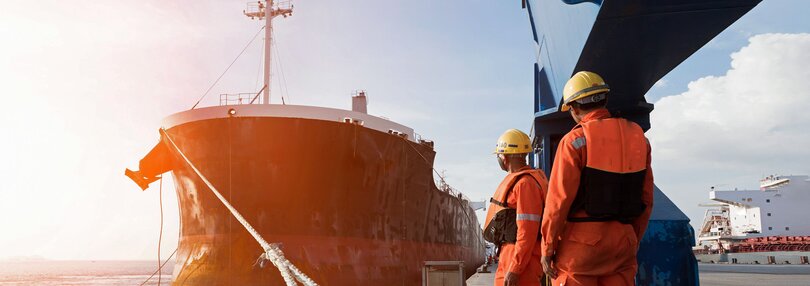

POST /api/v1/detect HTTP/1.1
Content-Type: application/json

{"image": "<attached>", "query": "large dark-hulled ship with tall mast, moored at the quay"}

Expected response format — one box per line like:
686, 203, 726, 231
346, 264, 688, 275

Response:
124, 1, 484, 285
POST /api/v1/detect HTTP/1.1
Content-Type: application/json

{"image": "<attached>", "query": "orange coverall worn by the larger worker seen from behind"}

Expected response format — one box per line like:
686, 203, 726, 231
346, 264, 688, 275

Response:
542, 109, 653, 286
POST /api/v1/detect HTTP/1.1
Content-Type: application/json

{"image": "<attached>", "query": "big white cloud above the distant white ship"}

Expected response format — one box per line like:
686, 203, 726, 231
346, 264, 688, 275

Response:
649, 34, 810, 230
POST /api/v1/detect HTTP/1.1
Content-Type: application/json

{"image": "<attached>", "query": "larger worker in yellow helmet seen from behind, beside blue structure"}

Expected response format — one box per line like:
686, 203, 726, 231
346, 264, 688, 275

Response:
541, 72, 653, 286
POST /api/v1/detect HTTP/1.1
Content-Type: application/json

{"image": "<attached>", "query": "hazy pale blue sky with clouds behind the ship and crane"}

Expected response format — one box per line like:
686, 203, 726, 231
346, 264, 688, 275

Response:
0, 0, 810, 260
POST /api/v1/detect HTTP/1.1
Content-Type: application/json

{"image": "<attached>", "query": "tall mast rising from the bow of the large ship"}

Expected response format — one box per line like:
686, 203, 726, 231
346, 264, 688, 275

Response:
242, 0, 293, 104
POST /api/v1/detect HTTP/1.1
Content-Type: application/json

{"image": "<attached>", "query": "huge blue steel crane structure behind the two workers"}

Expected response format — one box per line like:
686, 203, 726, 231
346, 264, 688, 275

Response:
524, 0, 761, 285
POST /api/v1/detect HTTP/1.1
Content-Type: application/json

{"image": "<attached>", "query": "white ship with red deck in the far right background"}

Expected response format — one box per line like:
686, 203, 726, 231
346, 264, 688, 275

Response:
694, 176, 810, 264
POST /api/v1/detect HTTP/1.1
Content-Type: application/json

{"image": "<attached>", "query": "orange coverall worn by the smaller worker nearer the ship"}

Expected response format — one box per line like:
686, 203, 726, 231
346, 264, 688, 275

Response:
486, 166, 548, 286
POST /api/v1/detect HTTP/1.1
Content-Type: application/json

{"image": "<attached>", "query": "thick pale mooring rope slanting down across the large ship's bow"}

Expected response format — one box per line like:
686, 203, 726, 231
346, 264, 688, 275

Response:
160, 128, 318, 286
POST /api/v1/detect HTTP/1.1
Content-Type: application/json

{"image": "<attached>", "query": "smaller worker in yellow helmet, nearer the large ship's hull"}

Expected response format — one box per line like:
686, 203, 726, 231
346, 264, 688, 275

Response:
484, 129, 548, 286
